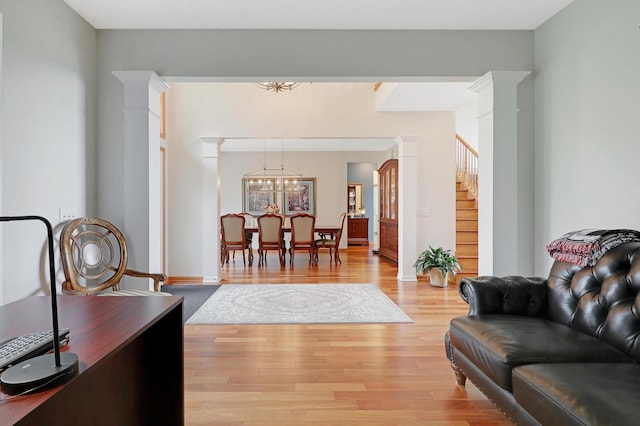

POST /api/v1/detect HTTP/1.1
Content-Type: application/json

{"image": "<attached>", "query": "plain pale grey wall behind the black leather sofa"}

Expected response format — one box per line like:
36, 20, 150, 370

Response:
535, 0, 640, 275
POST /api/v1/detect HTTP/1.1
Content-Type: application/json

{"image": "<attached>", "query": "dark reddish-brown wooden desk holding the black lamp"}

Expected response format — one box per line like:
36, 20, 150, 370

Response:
0, 296, 184, 425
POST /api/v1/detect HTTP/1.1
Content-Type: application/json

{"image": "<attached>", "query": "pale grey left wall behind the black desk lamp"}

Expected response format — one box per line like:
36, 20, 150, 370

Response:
0, 0, 96, 303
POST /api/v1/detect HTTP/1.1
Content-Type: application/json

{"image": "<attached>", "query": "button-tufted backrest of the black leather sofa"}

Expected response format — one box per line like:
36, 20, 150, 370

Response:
547, 242, 640, 362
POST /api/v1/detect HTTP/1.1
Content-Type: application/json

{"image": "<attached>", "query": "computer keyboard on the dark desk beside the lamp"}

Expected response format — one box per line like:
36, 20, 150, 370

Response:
0, 328, 69, 371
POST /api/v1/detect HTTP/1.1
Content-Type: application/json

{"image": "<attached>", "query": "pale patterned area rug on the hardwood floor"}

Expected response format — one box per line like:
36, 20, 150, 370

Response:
186, 284, 413, 324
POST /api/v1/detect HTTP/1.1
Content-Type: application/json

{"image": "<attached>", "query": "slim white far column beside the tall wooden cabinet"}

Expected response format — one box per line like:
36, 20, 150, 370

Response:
395, 136, 418, 281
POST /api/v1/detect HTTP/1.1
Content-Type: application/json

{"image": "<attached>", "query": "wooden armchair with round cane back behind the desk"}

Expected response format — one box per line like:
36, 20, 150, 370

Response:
60, 217, 171, 296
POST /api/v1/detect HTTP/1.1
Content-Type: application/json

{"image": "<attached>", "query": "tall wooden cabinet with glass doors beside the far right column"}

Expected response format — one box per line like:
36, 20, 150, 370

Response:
378, 159, 398, 262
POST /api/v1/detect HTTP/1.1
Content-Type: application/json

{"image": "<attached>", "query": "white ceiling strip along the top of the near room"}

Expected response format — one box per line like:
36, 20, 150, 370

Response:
65, 0, 573, 30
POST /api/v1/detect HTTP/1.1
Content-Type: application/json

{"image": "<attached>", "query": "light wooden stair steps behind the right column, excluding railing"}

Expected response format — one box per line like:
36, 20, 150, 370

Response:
456, 180, 478, 283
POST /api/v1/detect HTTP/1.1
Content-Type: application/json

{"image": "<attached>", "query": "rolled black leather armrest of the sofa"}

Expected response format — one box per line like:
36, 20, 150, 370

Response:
458, 276, 547, 317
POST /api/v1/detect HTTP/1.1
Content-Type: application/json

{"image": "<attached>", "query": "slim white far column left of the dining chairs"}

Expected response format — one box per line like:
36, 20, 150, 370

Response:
200, 138, 224, 283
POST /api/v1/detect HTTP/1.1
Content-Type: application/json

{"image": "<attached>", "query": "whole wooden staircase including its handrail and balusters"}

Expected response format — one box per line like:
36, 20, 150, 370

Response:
456, 135, 478, 283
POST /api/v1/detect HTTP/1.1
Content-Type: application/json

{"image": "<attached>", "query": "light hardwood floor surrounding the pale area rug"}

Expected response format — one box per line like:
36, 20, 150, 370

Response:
185, 247, 510, 426
